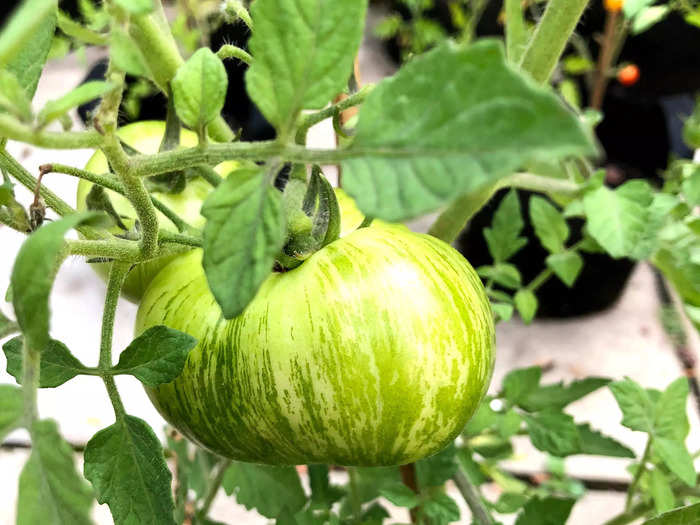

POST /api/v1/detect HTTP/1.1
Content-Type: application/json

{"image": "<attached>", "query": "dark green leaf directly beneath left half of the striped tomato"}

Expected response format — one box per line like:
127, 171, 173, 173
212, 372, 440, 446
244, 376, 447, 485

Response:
222, 462, 306, 518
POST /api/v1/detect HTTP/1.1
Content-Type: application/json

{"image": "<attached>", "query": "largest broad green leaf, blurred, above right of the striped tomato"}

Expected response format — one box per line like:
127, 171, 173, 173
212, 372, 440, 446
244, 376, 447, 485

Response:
341, 40, 594, 221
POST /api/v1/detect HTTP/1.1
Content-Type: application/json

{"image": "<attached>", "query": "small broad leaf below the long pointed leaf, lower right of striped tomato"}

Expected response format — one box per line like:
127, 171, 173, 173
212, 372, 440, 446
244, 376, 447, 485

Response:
523, 412, 581, 457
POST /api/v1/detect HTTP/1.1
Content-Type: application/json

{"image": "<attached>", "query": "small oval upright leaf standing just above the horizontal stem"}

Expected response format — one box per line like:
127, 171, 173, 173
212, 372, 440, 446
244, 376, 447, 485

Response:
171, 47, 228, 130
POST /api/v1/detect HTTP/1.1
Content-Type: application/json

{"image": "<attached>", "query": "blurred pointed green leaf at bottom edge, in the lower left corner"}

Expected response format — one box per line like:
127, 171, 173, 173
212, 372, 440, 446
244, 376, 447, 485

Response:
17, 419, 94, 525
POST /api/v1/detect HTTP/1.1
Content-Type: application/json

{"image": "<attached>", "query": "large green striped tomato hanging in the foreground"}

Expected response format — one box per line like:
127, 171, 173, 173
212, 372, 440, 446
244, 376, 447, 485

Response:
136, 225, 494, 466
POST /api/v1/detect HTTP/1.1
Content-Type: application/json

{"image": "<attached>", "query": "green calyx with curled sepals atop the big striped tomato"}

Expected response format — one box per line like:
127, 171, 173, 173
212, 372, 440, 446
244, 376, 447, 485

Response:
277, 165, 340, 270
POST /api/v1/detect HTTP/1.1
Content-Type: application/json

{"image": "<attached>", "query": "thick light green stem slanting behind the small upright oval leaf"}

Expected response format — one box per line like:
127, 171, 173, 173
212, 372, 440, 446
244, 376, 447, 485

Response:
129, 10, 234, 142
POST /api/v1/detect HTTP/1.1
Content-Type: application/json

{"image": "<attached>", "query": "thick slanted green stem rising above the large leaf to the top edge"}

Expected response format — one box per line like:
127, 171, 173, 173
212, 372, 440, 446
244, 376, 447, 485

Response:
520, 0, 588, 84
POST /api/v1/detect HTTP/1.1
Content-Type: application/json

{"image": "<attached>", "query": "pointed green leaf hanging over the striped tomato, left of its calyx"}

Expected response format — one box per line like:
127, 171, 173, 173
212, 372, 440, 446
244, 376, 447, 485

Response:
202, 168, 285, 319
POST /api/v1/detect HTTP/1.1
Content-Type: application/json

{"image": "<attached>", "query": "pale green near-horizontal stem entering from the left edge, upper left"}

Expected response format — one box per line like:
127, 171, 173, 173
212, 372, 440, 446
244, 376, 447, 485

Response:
0, 114, 102, 149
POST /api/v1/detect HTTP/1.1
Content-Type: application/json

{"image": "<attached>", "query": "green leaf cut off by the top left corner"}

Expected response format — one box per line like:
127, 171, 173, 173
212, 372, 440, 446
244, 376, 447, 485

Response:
0, 0, 58, 94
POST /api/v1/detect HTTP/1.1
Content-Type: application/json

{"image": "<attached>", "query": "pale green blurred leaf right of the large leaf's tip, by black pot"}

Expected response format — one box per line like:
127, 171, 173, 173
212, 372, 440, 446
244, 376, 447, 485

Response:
583, 181, 653, 257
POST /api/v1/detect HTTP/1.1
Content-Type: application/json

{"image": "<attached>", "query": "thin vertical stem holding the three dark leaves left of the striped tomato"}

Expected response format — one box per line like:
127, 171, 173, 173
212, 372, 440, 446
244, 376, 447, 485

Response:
99, 262, 130, 420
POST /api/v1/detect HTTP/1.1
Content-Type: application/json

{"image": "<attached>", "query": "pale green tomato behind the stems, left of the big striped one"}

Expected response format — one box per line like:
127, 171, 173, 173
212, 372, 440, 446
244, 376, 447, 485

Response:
77, 121, 237, 303
